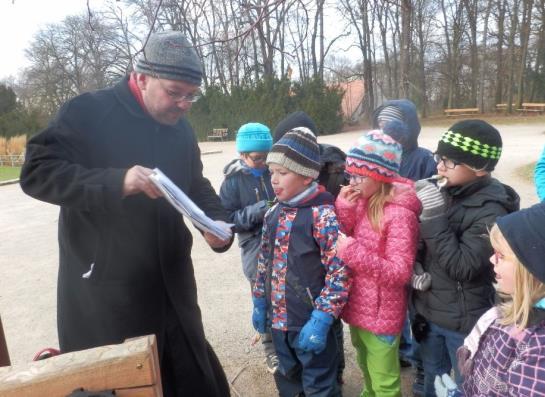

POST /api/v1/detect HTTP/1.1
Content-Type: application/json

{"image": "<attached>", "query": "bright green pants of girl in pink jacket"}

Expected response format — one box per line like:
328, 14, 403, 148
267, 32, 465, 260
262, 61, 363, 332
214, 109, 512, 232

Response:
350, 325, 401, 397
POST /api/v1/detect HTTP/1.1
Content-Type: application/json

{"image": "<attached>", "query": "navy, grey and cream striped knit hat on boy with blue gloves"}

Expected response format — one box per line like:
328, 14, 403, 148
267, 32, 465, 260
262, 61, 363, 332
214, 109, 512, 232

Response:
267, 127, 320, 179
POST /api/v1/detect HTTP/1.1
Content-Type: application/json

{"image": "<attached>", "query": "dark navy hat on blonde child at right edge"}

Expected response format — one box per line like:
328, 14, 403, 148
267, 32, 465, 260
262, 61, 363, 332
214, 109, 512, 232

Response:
496, 203, 545, 283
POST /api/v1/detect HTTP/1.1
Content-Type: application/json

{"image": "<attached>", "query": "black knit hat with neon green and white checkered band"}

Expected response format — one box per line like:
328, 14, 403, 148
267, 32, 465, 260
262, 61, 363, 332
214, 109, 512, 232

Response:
436, 120, 502, 171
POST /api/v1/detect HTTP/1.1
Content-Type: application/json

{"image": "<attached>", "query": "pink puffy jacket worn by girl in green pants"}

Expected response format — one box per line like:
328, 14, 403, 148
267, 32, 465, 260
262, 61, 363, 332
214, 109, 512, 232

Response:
335, 180, 421, 335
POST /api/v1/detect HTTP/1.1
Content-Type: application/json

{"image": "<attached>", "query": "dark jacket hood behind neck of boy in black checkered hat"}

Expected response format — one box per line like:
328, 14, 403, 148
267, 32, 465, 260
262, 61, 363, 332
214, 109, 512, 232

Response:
448, 175, 520, 213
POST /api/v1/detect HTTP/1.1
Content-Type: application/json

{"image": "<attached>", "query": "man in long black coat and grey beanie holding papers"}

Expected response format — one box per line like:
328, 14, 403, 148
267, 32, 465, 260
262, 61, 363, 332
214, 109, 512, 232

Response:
21, 32, 232, 396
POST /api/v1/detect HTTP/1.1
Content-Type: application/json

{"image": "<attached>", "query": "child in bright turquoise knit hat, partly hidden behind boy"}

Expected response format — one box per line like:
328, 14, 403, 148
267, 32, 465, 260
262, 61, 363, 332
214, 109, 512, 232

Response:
219, 123, 278, 374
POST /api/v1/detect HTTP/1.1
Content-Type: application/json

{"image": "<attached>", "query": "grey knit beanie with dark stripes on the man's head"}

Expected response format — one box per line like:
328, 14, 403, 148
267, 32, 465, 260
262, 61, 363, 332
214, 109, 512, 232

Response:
134, 31, 202, 86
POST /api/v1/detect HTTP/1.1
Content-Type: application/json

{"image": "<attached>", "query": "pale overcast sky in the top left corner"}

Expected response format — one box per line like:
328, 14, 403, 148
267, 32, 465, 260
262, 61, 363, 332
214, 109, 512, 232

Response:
0, 0, 101, 80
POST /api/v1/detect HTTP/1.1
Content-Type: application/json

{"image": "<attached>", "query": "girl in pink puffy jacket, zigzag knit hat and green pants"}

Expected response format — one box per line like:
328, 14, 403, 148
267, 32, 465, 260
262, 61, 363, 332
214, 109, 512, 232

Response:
335, 130, 421, 397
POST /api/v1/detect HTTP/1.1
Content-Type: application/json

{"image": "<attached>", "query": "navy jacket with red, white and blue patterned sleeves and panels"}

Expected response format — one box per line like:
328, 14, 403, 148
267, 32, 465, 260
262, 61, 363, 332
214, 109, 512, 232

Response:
253, 184, 350, 331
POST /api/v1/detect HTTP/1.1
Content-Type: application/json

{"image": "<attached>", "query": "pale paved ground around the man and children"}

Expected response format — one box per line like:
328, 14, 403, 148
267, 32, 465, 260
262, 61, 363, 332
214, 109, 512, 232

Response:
0, 124, 545, 397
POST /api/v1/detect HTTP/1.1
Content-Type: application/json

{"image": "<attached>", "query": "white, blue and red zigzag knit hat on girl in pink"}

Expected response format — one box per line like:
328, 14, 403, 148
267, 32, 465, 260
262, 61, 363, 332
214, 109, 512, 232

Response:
346, 130, 402, 183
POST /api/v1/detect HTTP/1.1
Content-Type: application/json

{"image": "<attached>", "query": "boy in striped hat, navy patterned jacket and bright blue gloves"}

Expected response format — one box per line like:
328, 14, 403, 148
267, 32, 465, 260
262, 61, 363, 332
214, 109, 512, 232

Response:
252, 127, 349, 397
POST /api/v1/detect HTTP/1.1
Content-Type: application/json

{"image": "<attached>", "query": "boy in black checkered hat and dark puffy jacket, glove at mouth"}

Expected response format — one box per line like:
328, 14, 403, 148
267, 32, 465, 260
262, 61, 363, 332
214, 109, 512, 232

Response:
413, 120, 519, 396
